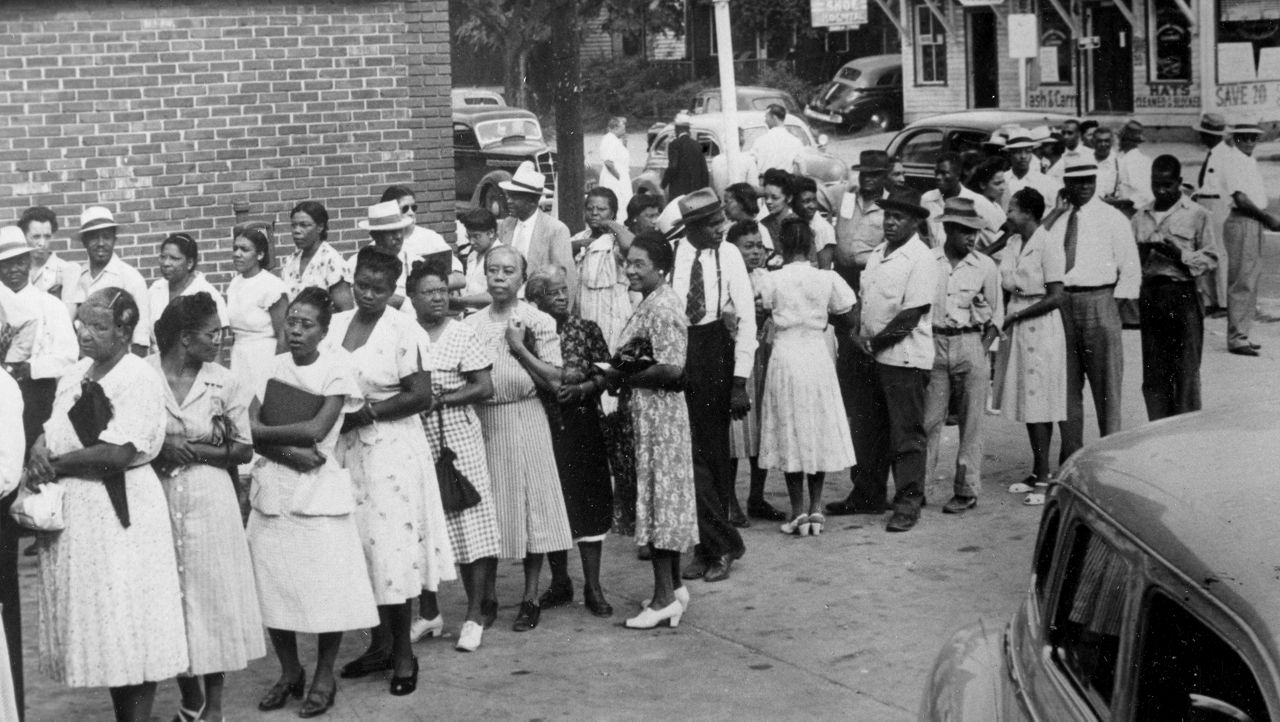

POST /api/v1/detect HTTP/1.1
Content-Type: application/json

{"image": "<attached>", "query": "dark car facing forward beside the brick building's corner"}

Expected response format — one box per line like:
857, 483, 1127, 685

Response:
453, 105, 556, 218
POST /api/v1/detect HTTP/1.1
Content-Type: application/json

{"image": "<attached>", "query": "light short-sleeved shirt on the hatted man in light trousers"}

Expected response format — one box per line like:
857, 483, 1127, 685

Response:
929, 248, 1005, 329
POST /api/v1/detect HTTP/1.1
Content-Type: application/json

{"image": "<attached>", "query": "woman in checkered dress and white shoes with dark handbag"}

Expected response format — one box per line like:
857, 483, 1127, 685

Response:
406, 261, 499, 652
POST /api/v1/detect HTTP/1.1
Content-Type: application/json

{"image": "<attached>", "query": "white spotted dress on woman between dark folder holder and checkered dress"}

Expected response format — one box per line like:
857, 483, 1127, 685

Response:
325, 307, 454, 604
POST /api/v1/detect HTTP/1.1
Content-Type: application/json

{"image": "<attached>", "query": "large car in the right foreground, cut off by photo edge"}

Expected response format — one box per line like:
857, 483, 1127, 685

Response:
919, 405, 1280, 722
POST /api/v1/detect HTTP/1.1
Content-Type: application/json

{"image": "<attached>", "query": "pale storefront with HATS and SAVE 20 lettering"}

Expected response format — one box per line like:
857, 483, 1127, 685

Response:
899, 0, 1280, 128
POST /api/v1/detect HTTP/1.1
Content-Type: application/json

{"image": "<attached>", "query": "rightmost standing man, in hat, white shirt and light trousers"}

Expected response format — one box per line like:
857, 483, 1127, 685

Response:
1219, 123, 1280, 356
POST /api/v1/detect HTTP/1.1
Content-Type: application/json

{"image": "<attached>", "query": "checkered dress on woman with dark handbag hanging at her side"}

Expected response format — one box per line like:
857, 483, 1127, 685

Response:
422, 320, 499, 565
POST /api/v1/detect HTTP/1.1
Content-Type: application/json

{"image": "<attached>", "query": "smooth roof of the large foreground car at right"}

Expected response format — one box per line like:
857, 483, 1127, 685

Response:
1064, 403, 1280, 654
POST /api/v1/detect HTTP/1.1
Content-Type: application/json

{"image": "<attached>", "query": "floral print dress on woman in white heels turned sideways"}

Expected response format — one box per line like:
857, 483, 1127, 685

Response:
613, 284, 698, 553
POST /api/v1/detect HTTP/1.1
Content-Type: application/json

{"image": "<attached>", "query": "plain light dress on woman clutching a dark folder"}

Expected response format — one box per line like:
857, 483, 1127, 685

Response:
248, 349, 378, 634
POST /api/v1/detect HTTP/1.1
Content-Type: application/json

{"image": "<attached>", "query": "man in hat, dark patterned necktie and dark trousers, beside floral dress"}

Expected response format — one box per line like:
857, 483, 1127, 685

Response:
671, 188, 756, 581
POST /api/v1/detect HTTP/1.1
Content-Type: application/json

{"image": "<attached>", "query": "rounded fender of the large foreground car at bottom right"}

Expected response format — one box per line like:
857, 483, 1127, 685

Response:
919, 621, 1023, 722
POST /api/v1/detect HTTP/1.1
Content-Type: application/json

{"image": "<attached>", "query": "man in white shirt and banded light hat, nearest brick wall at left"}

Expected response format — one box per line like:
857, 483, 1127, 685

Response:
69, 206, 151, 357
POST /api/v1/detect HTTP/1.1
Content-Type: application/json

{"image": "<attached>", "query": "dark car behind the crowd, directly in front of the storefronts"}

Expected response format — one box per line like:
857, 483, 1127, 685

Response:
887, 110, 1069, 191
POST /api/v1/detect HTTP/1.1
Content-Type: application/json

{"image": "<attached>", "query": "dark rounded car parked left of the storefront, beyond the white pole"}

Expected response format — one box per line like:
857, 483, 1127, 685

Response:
804, 54, 902, 133
